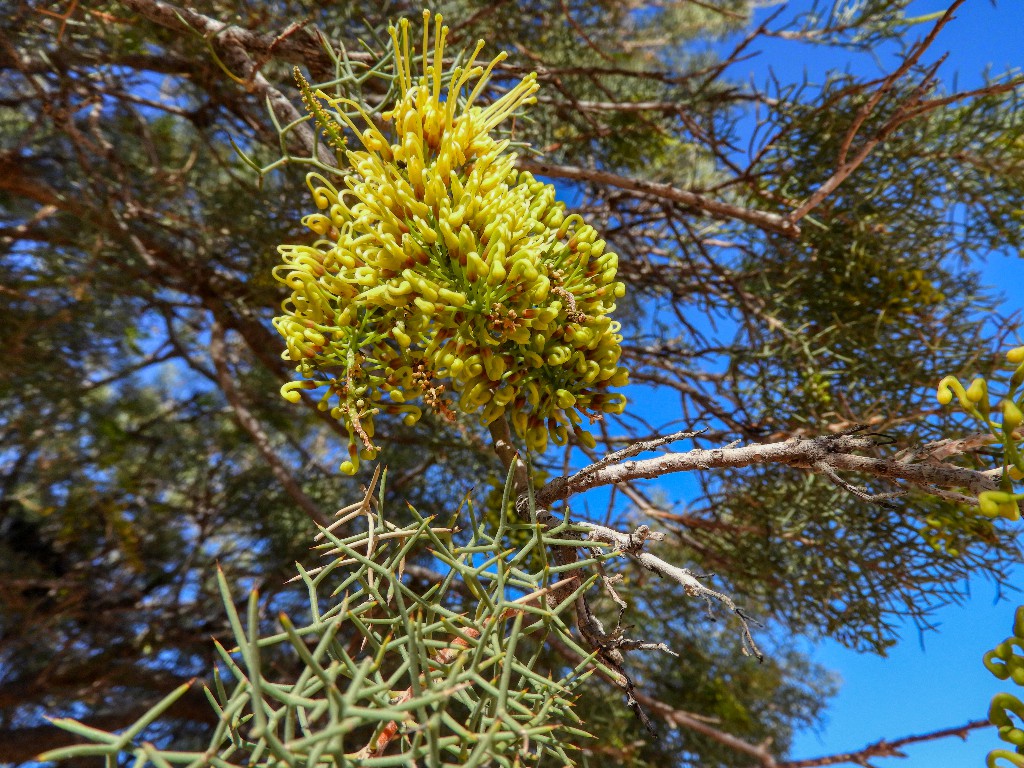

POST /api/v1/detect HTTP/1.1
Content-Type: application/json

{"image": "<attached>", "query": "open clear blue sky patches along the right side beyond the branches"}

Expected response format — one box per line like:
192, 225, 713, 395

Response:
716, 0, 1024, 768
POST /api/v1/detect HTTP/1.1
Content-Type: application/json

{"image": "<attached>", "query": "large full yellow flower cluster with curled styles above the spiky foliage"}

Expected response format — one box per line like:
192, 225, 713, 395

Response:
274, 11, 628, 473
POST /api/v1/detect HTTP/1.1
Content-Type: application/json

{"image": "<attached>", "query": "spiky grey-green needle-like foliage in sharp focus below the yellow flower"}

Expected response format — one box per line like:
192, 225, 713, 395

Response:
40, 473, 594, 768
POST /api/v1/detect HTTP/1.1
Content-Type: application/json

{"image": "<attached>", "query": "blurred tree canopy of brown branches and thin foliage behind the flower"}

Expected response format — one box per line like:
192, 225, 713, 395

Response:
0, 0, 1024, 766
